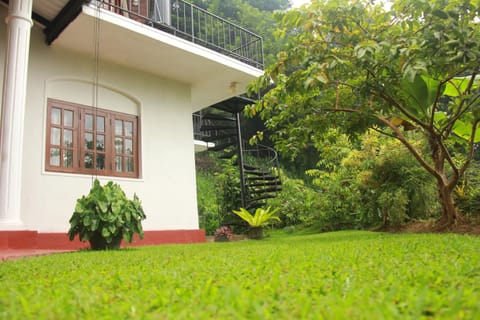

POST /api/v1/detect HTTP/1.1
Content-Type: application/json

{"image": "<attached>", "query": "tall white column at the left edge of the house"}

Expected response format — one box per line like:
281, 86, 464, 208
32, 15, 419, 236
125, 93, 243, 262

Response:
0, 0, 33, 230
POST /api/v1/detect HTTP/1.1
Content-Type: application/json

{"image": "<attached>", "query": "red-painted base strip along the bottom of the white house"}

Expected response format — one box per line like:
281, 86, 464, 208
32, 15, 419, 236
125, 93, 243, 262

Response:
0, 230, 206, 250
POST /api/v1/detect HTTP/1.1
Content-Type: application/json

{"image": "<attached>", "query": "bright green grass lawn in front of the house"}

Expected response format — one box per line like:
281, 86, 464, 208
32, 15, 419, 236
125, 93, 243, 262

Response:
0, 231, 480, 320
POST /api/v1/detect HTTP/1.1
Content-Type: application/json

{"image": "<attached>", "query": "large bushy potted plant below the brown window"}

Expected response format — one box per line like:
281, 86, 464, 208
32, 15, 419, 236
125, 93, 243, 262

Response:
68, 179, 146, 250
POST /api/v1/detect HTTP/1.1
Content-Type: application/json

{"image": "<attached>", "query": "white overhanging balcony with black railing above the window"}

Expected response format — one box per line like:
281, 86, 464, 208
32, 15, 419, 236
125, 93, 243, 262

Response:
47, 0, 263, 112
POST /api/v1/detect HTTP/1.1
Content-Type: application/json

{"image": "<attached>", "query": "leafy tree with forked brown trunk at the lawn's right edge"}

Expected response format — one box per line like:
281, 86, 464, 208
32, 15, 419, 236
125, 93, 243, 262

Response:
247, 0, 480, 227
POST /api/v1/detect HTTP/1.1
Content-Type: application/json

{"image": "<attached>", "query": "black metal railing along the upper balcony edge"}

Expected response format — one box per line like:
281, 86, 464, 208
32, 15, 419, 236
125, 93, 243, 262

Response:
92, 0, 264, 69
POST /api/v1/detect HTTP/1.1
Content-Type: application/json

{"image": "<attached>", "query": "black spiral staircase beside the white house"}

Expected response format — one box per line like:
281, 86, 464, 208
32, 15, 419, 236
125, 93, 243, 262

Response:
194, 97, 282, 209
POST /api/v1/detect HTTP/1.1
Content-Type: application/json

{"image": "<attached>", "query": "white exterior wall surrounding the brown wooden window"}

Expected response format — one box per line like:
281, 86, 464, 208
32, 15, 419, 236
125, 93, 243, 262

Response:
0, 7, 198, 232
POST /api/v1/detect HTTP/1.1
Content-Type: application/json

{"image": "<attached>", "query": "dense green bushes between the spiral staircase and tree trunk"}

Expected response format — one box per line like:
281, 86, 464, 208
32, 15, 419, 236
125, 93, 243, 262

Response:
307, 129, 439, 230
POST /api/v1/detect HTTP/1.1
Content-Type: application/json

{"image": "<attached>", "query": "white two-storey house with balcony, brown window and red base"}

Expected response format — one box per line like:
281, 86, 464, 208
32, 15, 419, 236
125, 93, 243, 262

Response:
0, 0, 262, 249
